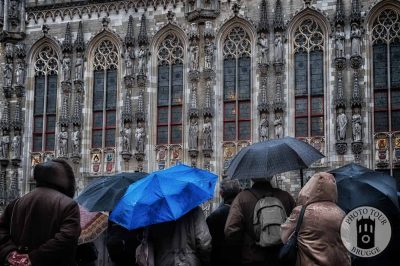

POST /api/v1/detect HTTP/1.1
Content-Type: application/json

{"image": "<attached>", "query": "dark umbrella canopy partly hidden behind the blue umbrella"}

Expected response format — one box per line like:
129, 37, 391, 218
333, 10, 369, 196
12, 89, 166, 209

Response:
75, 172, 147, 211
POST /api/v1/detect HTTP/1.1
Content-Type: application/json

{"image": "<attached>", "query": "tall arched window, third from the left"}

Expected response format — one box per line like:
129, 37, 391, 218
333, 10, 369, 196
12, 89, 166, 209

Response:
157, 33, 183, 144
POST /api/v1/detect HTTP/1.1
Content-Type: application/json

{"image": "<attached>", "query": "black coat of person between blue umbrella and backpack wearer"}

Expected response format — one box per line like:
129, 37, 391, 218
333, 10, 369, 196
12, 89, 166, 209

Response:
207, 199, 242, 266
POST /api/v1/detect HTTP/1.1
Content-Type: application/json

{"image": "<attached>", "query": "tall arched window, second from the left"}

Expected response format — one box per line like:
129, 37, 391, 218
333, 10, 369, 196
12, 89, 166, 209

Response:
92, 40, 118, 148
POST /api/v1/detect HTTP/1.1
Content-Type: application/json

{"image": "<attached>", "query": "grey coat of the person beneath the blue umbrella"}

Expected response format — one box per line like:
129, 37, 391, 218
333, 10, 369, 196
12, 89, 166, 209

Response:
150, 207, 211, 266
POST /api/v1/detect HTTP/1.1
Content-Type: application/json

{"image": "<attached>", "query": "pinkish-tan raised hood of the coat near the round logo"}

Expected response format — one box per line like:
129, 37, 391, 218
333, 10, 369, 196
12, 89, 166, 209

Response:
297, 172, 337, 205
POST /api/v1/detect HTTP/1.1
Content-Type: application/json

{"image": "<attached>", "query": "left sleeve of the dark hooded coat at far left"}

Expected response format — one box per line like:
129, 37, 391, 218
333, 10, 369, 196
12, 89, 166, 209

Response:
0, 201, 17, 265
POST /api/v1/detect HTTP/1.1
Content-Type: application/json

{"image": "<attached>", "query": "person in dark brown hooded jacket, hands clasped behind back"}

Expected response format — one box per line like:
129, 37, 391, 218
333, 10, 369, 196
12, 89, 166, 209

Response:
0, 159, 81, 266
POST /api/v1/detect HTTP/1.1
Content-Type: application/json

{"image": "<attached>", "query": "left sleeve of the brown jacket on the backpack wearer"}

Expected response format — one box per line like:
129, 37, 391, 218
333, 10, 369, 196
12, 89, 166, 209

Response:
224, 195, 245, 243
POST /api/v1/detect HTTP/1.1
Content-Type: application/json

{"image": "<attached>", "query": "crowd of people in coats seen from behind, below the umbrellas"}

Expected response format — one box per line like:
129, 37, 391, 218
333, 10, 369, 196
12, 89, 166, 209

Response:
0, 159, 394, 266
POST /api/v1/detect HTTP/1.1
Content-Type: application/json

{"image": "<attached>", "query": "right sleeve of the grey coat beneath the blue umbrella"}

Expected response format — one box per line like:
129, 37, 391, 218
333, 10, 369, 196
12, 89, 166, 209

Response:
195, 208, 211, 265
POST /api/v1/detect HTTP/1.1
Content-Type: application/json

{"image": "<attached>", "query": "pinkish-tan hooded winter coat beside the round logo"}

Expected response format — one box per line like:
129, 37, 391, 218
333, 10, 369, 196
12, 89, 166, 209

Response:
281, 173, 350, 266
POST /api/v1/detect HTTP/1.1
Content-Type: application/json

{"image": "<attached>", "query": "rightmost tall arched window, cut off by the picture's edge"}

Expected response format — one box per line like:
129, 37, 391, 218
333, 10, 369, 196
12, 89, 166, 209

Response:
372, 9, 400, 133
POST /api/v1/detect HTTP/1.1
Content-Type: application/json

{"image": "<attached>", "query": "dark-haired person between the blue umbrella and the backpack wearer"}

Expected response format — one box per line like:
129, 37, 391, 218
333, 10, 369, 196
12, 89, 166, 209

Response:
207, 179, 241, 266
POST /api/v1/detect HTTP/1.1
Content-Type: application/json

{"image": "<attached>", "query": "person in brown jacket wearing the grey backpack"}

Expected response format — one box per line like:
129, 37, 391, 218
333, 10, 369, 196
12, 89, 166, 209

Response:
224, 178, 295, 266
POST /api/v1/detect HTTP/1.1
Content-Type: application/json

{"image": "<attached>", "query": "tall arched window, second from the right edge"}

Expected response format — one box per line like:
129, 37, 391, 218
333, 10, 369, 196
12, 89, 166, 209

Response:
294, 19, 324, 137
